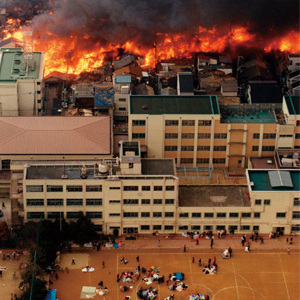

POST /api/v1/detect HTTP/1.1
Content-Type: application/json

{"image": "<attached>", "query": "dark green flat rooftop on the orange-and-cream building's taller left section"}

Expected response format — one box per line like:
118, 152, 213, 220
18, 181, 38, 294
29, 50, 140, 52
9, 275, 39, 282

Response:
129, 95, 220, 115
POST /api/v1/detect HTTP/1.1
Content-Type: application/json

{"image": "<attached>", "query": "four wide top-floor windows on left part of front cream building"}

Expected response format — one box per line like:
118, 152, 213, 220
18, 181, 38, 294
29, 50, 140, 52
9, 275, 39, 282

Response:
26, 185, 102, 193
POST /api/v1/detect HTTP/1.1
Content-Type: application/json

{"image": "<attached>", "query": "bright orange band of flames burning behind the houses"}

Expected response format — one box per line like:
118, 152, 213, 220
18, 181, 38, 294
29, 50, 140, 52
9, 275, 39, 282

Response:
2, 19, 300, 75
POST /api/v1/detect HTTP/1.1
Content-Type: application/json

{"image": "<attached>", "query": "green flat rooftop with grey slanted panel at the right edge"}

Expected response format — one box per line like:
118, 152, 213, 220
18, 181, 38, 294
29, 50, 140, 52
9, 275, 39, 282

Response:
247, 170, 300, 192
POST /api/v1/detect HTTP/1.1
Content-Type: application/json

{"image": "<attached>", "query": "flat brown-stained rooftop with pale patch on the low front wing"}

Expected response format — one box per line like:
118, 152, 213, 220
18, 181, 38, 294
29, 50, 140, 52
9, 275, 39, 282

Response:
178, 185, 251, 207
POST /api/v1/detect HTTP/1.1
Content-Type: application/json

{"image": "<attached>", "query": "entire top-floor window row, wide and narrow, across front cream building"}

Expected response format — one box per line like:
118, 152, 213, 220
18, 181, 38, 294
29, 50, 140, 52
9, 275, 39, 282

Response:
26, 185, 175, 193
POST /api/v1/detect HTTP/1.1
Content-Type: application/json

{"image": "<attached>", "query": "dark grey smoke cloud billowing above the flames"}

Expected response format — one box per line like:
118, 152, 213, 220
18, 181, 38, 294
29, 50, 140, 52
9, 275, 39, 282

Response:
33, 0, 299, 47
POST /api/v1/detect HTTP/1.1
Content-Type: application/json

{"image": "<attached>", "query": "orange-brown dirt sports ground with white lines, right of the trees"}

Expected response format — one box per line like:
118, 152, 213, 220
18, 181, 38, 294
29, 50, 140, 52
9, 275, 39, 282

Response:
48, 248, 300, 300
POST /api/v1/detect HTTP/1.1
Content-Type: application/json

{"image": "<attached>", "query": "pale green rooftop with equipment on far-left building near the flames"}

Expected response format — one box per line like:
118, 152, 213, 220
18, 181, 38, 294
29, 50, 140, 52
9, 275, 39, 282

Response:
0, 48, 42, 83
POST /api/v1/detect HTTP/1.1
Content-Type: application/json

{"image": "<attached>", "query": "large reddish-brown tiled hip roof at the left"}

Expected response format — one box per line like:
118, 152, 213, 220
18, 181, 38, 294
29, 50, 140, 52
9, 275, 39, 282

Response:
0, 117, 111, 155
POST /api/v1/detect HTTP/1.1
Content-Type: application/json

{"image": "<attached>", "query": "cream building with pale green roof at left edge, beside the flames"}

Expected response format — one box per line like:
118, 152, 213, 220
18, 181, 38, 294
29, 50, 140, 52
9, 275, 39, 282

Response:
0, 48, 45, 116
